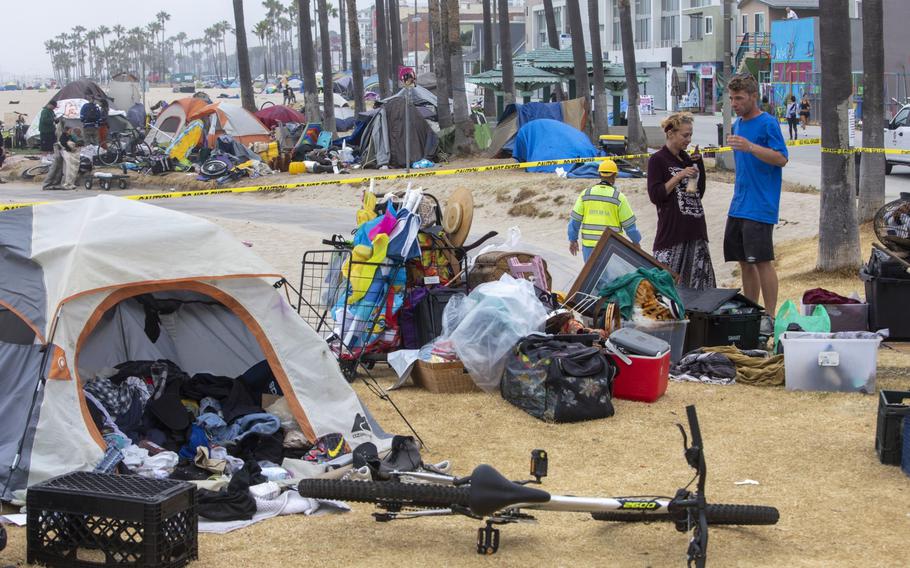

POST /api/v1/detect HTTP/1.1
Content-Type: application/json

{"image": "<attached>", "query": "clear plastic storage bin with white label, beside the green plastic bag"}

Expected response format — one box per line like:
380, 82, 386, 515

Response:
781, 331, 882, 393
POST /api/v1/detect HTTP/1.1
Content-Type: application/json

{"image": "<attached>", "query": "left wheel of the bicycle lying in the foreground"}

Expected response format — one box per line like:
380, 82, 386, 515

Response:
297, 479, 469, 508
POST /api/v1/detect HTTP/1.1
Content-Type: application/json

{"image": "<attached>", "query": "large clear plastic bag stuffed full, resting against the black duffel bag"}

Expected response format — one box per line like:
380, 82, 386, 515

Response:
446, 274, 547, 392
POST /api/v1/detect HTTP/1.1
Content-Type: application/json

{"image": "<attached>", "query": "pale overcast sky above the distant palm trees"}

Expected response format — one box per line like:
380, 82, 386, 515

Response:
0, 0, 390, 80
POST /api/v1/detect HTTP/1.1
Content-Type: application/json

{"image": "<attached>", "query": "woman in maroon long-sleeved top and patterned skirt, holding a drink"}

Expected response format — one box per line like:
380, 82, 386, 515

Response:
648, 112, 715, 290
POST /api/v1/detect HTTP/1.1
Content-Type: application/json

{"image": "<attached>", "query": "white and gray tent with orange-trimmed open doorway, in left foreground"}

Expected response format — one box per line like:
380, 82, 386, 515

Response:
0, 196, 390, 500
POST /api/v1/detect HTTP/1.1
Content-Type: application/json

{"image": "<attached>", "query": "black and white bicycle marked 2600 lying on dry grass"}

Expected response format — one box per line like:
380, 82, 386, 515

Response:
298, 406, 780, 568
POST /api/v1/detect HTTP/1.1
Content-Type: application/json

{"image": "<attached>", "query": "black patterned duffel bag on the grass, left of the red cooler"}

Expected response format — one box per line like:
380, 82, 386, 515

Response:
500, 334, 617, 422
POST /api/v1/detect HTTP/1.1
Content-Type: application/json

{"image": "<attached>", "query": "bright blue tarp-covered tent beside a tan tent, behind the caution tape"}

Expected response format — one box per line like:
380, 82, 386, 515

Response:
512, 118, 602, 172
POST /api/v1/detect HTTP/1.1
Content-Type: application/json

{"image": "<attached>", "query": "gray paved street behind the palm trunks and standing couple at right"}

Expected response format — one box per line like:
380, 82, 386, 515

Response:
642, 113, 910, 198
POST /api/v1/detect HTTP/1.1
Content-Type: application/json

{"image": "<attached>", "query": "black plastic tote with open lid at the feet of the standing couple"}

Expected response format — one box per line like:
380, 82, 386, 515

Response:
678, 288, 764, 353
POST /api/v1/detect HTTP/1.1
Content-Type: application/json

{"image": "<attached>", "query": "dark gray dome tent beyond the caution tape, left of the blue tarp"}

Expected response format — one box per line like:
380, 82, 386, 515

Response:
360, 94, 439, 168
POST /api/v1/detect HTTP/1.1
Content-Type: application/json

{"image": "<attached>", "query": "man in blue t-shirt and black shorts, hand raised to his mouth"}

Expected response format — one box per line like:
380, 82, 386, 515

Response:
724, 74, 789, 335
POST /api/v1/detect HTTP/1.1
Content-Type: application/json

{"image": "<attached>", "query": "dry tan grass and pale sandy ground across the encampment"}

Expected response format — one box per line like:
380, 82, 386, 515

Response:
0, 85, 910, 567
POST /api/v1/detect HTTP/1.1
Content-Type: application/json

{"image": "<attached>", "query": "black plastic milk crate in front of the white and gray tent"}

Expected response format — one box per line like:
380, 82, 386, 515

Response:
26, 472, 199, 568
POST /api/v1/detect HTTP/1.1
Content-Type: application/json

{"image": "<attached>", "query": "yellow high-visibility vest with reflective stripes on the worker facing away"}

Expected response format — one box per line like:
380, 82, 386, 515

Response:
570, 183, 635, 248
